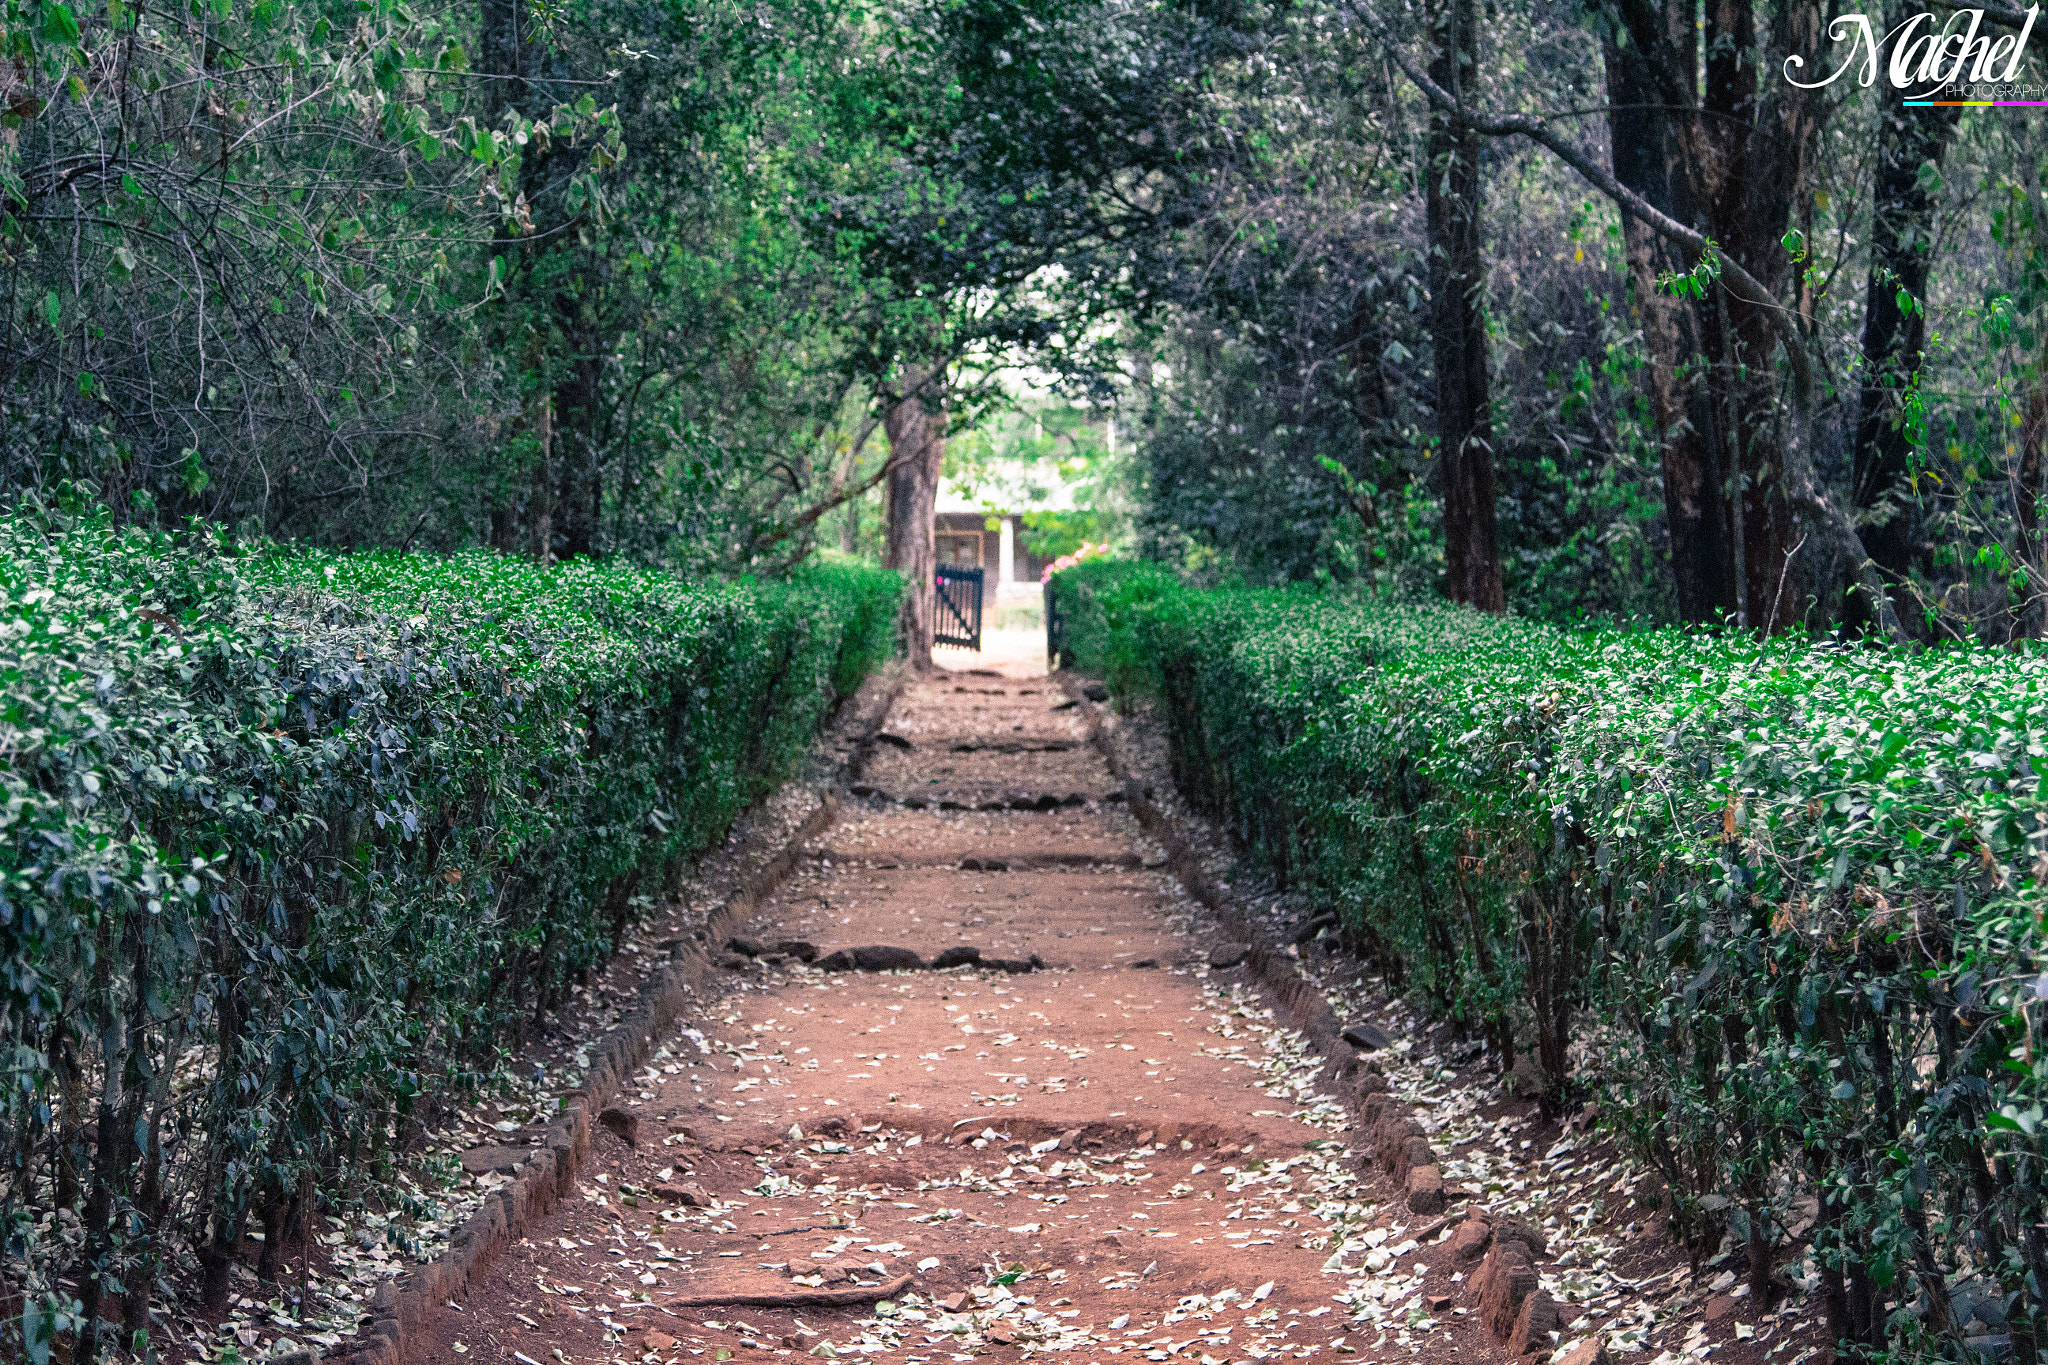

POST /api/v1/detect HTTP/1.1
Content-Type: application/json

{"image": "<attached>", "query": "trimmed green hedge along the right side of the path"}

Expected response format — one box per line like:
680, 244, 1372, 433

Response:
1055, 565, 2048, 1361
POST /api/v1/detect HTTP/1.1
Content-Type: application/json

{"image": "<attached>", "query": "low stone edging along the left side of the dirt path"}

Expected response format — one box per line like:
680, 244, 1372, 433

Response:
327, 667, 909, 1365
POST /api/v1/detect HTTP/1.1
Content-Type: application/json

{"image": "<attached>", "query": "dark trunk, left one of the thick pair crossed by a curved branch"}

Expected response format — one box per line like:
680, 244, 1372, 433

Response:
1606, 14, 1735, 622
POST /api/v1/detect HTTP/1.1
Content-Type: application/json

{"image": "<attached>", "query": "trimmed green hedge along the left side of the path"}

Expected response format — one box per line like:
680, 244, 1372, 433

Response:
0, 512, 901, 1353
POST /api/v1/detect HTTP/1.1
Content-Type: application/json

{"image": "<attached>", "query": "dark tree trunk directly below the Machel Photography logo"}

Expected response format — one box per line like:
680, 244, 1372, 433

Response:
1853, 46, 1958, 626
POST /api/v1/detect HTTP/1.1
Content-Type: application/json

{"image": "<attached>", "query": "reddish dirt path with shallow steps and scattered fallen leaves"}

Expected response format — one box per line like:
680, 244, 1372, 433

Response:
418, 661, 1501, 1365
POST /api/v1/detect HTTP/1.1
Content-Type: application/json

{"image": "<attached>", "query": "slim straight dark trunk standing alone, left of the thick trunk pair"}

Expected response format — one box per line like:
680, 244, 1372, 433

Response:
1425, 0, 1507, 612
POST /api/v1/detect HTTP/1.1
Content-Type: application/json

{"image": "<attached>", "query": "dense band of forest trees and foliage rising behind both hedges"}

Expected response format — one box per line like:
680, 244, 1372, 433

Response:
0, 0, 2048, 641
